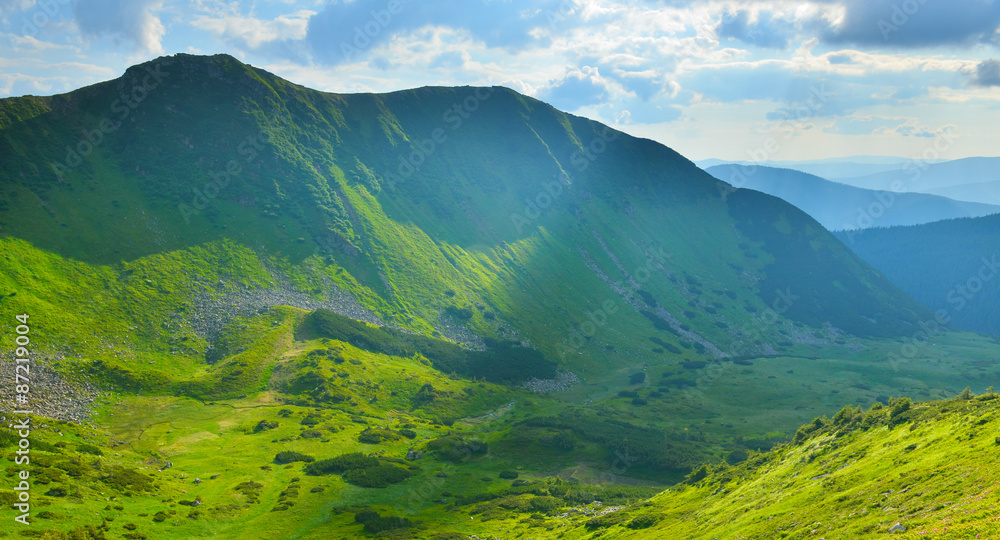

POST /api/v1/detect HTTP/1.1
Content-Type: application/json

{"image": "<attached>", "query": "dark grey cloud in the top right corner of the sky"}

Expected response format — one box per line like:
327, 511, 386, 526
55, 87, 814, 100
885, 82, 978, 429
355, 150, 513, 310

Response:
823, 0, 1000, 48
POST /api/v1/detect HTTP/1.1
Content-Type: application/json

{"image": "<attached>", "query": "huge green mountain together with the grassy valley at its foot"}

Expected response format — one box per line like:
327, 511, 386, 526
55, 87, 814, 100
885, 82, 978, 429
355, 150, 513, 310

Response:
0, 55, 1000, 538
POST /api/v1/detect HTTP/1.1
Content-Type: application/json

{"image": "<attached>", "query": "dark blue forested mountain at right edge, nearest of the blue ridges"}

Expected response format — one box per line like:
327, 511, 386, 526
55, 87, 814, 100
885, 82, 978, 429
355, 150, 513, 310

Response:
836, 215, 1000, 336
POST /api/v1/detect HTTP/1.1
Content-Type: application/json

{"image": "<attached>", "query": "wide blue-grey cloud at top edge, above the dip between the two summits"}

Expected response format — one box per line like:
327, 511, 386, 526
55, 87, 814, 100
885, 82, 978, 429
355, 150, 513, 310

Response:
306, 0, 572, 64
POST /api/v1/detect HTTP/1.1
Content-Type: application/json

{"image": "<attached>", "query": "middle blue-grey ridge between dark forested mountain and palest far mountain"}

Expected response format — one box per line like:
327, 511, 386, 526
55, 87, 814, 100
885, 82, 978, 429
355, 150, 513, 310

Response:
706, 165, 1000, 230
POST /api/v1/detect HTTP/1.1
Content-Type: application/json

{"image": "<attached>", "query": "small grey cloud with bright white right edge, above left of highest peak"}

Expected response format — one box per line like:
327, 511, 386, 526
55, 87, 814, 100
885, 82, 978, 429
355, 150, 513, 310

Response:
73, 0, 166, 54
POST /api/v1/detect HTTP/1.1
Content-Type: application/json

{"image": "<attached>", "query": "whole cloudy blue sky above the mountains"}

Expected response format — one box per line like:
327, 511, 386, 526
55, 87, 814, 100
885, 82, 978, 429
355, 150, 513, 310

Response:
0, 0, 1000, 161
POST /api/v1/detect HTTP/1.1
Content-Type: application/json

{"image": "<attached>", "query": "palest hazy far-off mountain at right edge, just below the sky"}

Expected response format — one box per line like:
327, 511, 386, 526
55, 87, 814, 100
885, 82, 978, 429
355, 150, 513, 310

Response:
831, 157, 1000, 204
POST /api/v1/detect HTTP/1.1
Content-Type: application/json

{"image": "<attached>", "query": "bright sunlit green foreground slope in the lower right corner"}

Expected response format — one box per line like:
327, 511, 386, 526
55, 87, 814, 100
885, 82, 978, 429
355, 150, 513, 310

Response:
548, 393, 1000, 539
